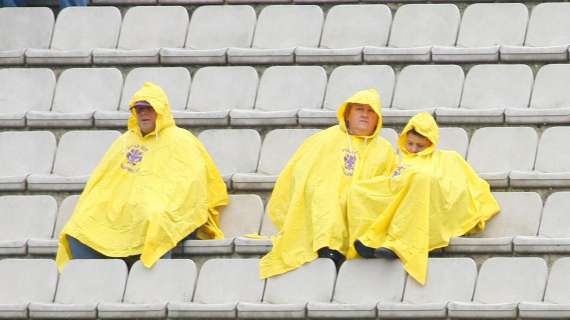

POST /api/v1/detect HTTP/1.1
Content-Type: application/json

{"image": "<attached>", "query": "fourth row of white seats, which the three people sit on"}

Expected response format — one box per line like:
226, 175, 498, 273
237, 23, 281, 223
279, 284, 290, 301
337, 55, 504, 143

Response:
0, 191, 570, 257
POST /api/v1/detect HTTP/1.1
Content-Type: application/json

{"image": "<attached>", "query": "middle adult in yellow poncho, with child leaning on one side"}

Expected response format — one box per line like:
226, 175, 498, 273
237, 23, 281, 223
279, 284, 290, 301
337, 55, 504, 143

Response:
260, 90, 396, 278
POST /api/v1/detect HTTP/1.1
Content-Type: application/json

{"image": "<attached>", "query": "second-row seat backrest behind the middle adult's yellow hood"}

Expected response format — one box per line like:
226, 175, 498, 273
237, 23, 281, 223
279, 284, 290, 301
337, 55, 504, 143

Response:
323, 65, 396, 110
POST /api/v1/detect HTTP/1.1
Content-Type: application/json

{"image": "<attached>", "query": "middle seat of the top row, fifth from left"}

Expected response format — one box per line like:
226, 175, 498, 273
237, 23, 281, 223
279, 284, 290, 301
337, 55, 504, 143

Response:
227, 5, 324, 64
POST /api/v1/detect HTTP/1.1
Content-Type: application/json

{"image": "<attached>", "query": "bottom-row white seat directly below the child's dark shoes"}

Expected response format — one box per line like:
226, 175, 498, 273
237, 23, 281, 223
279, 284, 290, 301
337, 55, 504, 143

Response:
307, 259, 406, 319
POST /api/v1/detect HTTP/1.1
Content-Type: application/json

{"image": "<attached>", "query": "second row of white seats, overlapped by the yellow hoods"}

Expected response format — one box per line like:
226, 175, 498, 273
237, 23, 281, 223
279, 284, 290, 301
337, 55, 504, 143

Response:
4, 64, 570, 128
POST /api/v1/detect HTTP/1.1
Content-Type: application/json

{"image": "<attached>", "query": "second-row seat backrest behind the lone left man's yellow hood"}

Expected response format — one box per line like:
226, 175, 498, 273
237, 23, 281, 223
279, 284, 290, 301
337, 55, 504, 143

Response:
119, 67, 191, 110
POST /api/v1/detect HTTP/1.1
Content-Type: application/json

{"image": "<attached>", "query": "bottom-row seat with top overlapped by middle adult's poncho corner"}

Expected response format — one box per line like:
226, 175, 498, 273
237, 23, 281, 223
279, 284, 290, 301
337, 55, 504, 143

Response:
237, 258, 336, 319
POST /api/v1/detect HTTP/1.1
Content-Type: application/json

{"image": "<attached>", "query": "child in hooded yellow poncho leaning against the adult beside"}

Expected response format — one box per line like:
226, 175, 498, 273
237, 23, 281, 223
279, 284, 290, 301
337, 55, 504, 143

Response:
348, 112, 500, 284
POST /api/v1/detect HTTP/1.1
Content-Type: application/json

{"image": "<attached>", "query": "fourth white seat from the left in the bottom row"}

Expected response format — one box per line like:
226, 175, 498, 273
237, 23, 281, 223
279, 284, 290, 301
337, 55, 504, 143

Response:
168, 258, 265, 319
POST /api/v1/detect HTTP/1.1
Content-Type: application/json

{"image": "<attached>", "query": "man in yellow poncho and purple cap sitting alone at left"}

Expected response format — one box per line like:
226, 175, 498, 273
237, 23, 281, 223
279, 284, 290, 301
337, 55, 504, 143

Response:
56, 82, 228, 270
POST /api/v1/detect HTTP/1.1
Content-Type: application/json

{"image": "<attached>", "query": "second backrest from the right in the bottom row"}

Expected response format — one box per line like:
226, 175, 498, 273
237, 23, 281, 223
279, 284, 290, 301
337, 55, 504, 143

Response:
473, 257, 548, 303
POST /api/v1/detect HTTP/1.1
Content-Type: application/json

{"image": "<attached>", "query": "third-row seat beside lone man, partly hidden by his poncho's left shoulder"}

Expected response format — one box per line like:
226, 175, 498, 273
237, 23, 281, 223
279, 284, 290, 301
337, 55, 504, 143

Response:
27, 130, 120, 191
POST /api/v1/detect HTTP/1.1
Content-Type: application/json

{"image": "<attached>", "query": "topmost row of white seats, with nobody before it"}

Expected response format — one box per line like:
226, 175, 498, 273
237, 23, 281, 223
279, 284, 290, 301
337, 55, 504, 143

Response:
5, 0, 570, 65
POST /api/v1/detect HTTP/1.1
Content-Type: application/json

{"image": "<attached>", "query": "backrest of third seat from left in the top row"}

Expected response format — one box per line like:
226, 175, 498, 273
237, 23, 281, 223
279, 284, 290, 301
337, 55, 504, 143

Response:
118, 6, 190, 49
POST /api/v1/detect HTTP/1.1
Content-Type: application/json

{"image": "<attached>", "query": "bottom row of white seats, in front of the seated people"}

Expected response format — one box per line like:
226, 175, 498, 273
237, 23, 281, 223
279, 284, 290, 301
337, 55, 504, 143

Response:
0, 257, 570, 319
